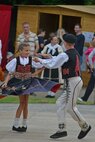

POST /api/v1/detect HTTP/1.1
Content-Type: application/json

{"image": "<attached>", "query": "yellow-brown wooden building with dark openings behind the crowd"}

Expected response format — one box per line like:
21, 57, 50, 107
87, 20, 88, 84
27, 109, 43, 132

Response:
16, 5, 95, 86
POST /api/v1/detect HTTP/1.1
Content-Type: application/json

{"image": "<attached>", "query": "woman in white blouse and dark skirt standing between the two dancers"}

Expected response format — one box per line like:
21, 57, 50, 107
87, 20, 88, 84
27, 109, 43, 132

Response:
41, 36, 63, 98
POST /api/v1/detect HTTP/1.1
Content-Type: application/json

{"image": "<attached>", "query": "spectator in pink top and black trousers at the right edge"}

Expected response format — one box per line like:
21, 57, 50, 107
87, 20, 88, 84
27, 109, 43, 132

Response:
78, 40, 95, 102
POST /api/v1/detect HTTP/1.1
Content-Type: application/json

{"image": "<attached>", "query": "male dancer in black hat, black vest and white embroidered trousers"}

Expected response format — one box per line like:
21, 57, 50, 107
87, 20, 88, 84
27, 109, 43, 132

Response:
35, 34, 91, 139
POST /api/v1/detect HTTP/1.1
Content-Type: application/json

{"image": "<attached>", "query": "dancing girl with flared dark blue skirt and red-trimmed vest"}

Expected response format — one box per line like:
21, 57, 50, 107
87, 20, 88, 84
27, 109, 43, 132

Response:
2, 43, 60, 132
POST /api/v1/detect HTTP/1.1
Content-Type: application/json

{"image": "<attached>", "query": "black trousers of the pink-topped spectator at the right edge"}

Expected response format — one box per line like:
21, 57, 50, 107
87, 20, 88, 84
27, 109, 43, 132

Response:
81, 73, 95, 101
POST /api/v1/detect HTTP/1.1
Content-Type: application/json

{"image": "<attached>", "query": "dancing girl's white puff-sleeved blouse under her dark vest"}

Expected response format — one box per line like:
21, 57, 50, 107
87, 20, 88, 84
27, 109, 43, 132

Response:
6, 57, 43, 73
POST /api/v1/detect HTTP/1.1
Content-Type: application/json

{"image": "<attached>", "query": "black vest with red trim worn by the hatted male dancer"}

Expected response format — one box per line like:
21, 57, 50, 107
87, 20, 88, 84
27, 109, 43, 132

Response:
62, 48, 80, 79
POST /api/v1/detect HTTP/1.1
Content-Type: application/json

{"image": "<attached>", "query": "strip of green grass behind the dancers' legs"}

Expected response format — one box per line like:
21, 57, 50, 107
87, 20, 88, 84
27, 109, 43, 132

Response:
0, 96, 93, 105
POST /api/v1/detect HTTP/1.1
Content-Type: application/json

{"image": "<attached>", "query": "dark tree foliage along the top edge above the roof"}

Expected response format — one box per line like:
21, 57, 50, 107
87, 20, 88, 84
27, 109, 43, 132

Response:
0, 0, 95, 5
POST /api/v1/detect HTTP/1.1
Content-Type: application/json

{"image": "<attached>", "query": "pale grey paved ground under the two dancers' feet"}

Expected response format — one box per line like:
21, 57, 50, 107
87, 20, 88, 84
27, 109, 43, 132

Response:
0, 104, 95, 142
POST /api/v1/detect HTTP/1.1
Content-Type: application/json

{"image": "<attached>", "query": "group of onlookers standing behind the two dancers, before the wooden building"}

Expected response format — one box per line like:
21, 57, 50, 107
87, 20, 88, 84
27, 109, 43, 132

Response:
0, 22, 94, 98
